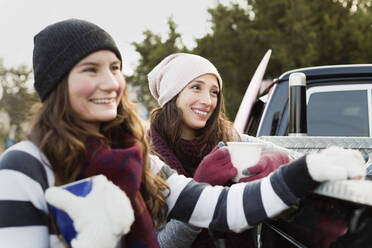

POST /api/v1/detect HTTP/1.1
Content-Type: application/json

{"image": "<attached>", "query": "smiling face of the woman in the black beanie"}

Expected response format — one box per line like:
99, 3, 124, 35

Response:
67, 50, 125, 131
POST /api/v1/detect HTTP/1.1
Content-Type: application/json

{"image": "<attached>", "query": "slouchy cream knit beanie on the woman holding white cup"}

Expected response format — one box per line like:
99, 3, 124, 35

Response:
147, 53, 222, 107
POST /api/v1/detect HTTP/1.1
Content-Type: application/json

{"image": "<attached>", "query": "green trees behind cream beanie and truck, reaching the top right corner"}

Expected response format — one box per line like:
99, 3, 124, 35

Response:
130, 0, 372, 119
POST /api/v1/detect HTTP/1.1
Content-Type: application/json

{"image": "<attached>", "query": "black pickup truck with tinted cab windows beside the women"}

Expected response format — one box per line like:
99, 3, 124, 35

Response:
234, 64, 372, 247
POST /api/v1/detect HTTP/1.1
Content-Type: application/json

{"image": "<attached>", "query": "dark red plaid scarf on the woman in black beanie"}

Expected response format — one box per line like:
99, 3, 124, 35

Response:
82, 135, 159, 248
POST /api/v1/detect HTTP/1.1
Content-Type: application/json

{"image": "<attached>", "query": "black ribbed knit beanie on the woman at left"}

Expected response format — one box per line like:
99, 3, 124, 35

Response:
33, 19, 122, 101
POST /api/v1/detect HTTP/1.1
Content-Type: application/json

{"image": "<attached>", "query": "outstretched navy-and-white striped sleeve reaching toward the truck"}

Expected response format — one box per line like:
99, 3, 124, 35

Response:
150, 154, 316, 232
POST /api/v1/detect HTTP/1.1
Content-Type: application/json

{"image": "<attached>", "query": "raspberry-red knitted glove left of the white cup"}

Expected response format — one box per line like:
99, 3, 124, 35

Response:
194, 147, 238, 186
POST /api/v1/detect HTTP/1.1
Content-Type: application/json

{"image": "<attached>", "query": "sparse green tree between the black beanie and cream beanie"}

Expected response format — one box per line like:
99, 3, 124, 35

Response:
127, 18, 187, 110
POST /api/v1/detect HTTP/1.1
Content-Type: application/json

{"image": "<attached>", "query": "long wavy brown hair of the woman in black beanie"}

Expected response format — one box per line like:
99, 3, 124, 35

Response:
30, 78, 169, 227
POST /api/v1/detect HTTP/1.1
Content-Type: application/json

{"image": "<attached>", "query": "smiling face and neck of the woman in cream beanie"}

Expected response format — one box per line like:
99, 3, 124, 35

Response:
176, 74, 219, 140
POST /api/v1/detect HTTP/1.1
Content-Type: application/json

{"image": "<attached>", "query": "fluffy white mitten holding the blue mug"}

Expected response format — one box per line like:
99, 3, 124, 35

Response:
45, 175, 134, 248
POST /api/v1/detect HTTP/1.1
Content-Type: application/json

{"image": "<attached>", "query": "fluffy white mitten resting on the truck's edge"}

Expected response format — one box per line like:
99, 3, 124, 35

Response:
306, 147, 366, 182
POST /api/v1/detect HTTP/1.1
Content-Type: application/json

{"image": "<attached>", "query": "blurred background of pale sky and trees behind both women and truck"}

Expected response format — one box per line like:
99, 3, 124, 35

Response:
0, 0, 372, 152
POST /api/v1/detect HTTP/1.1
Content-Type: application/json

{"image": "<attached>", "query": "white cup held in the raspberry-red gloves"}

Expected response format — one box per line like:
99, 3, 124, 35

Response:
227, 142, 263, 182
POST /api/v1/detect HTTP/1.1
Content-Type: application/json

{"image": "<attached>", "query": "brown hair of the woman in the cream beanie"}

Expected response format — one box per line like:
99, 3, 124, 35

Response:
150, 88, 235, 155
